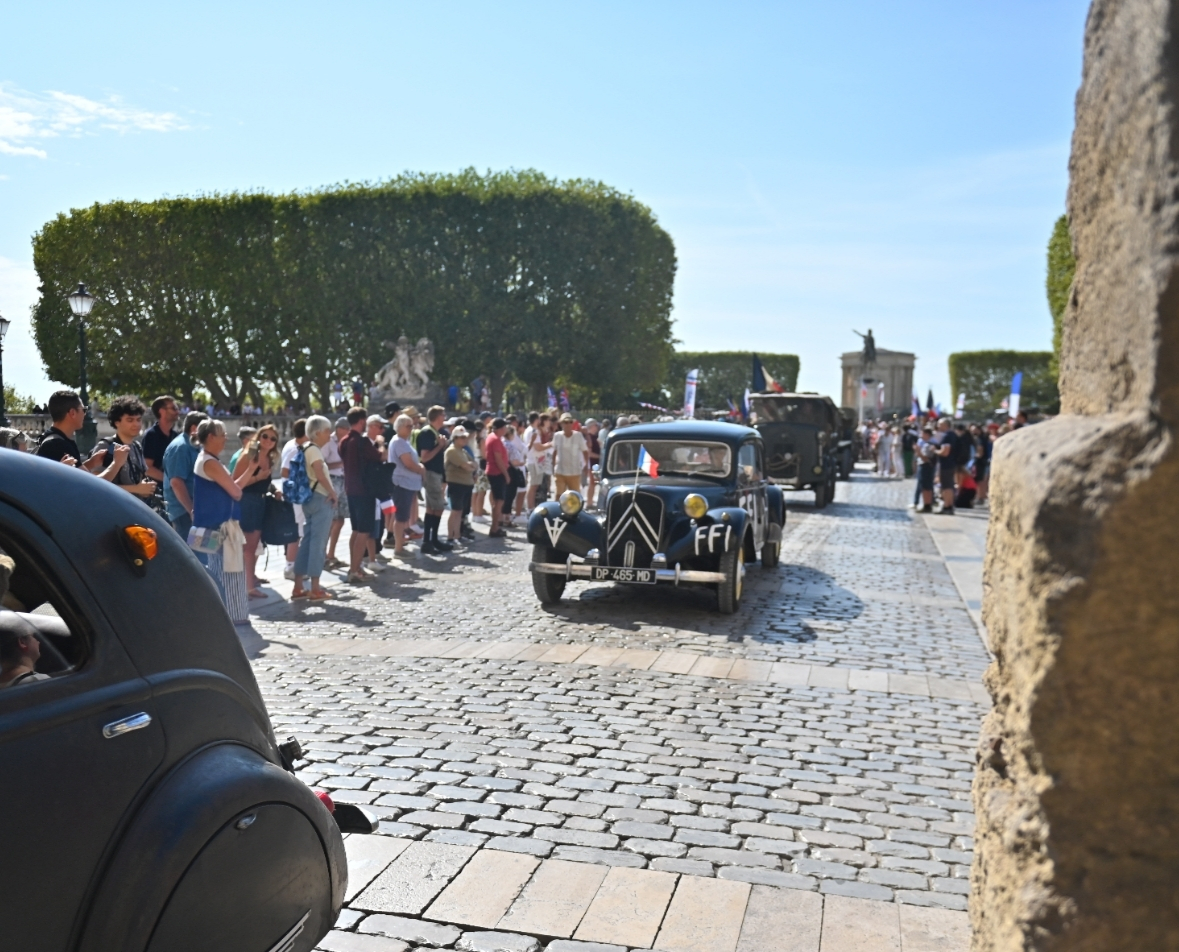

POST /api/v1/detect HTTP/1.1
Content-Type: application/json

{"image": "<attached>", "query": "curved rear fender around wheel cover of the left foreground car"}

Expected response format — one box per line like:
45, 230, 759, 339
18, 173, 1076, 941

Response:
78, 743, 348, 952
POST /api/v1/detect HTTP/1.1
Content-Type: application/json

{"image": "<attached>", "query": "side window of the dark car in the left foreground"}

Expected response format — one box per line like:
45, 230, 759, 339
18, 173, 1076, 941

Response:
0, 527, 90, 692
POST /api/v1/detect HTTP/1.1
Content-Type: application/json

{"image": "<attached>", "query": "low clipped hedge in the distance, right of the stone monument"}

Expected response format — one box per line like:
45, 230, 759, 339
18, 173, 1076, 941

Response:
950, 350, 1060, 420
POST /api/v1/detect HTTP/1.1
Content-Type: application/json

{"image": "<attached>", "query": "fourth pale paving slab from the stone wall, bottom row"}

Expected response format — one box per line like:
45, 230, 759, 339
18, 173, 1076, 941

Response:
656, 877, 750, 952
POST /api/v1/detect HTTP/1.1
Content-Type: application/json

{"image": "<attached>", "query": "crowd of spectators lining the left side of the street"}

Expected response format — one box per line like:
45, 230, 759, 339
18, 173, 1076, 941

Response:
9, 390, 613, 623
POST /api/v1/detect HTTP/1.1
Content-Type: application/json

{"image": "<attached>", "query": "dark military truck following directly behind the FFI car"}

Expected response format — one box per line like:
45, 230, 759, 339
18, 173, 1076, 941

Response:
750, 393, 850, 508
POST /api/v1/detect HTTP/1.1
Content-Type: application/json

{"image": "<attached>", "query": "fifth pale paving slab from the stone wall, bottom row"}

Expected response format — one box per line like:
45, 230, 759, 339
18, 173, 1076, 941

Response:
574, 867, 678, 948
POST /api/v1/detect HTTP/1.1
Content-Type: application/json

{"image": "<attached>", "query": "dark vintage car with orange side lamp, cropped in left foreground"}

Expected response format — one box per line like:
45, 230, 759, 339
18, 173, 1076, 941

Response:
0, 449, 373, 952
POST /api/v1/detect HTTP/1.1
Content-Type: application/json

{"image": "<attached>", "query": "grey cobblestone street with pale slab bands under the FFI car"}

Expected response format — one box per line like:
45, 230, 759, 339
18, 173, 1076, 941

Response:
248, 473, 988, 952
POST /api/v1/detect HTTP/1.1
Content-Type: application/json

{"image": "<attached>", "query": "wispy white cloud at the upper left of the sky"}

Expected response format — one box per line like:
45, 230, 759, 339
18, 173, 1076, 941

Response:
0, 85, 187, 158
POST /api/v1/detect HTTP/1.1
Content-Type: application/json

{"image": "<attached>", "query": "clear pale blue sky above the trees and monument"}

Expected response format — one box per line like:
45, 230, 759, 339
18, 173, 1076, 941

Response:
0, 0, 1086, 403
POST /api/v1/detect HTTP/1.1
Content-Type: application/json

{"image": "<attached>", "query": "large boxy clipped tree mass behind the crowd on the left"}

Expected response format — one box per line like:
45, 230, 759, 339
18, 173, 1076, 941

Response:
33, 170, 676, 407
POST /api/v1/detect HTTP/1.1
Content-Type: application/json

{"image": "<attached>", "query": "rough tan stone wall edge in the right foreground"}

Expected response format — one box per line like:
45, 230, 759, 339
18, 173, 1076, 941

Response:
970, 0, 1179, 952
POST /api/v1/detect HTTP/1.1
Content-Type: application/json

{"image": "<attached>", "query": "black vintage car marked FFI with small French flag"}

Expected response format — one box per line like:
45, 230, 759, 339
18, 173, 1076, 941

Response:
528, 420, 785, 613
